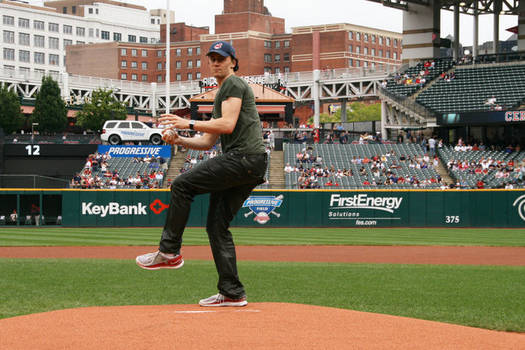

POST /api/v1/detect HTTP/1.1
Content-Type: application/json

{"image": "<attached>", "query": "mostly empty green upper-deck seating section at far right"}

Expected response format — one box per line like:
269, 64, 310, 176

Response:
416, 64, 525, 114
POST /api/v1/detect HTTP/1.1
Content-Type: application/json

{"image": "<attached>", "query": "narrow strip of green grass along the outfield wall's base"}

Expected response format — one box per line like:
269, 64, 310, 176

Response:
0, 227, 525, 247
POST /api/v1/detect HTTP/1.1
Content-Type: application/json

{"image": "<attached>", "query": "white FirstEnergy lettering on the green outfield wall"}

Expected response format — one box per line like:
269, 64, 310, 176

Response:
330, 194, 403, 213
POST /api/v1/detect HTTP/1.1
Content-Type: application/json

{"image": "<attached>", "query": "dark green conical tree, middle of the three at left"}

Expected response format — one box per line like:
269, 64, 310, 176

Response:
31, 76, 67, 133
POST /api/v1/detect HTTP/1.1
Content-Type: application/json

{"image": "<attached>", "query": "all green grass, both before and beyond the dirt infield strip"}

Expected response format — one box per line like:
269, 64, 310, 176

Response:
0, 228, 525, 332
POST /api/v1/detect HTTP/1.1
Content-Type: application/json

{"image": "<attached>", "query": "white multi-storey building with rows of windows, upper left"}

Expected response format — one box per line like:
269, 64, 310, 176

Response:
0, 0, 165, 74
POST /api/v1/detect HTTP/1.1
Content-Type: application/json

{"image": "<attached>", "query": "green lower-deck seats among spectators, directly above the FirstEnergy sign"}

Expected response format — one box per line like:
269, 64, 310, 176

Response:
284, 144, 440, 189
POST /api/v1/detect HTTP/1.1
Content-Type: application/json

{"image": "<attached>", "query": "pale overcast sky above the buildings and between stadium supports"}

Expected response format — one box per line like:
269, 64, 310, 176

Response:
32, 0, 518, 46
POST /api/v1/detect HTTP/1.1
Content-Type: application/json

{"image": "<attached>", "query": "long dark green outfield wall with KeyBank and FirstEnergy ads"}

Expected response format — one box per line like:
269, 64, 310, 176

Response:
0, 189, 525, 227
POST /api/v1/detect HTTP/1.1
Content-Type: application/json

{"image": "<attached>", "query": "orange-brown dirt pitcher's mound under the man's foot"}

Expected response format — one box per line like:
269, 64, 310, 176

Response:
0, 303, 525, 350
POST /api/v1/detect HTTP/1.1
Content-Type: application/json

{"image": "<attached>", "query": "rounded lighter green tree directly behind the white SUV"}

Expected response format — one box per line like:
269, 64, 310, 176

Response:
77, 89, 127, 131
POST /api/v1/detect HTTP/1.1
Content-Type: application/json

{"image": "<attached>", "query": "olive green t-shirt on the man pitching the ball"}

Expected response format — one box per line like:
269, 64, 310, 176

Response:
212, 75, 265, 154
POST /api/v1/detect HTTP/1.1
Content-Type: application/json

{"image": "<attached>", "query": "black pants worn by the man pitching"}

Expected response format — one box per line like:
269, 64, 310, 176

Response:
159, 152, 268, 299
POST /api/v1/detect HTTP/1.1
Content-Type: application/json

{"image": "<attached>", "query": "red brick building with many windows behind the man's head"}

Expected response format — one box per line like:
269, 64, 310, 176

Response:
66, 0, 402, 82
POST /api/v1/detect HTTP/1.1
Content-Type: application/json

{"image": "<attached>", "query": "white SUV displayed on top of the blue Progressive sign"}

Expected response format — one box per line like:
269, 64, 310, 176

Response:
100, 120, 162, 145
